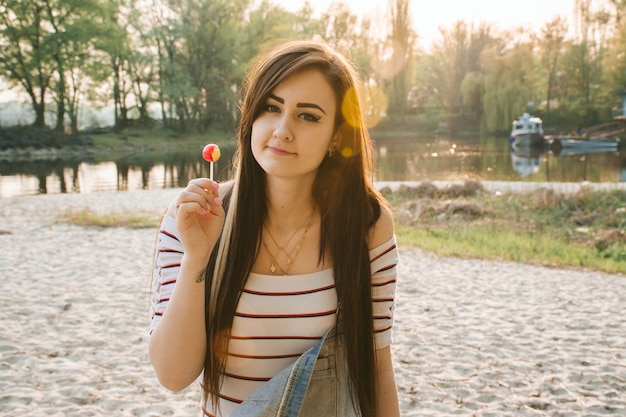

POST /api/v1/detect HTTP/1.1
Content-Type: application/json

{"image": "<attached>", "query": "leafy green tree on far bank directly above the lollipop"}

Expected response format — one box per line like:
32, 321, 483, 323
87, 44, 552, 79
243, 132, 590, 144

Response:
150, 0, 249, 132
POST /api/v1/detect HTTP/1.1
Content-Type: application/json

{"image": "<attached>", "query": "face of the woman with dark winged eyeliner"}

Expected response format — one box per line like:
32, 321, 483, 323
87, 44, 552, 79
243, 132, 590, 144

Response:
251, 69, 337, 182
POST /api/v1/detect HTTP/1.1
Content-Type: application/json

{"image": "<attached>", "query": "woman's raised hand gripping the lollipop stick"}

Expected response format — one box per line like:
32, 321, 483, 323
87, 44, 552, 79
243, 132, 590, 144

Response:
175, 178, 225, 261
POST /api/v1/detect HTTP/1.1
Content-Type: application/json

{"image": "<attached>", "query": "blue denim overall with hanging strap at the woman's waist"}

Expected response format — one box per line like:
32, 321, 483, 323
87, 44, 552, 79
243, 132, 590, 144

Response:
230, 326, 358, 417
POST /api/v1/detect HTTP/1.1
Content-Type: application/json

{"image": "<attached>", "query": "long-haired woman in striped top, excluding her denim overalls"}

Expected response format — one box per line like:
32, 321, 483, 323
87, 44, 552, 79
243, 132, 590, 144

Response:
150, 41, 399, 417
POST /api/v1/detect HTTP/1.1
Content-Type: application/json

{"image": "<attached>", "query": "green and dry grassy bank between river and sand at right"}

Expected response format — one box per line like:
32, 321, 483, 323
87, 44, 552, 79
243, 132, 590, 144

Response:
385, 184, 626, 273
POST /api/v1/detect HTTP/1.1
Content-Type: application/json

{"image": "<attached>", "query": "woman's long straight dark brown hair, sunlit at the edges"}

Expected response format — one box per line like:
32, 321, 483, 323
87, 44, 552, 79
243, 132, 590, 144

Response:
203, 41, 385, 417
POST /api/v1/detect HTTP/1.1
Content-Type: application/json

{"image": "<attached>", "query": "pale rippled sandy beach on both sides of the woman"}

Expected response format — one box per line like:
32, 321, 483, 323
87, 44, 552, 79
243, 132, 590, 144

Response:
0, 190, 626, 417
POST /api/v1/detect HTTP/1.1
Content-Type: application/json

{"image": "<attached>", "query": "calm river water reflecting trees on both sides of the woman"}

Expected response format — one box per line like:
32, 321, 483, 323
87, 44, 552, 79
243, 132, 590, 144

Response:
0, 136, 626, 198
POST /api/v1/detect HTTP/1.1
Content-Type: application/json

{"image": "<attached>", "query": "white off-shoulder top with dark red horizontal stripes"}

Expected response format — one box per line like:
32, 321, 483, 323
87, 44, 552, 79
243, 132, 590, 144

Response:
150, 215, 398, 416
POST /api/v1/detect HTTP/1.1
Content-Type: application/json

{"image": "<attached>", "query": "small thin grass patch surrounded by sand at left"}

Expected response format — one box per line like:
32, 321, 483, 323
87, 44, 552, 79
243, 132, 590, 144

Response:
57, 209, 159, 229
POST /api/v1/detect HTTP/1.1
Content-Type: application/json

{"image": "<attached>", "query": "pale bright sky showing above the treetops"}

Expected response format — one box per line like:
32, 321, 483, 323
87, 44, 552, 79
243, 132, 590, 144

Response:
274, 0, 575, 48
